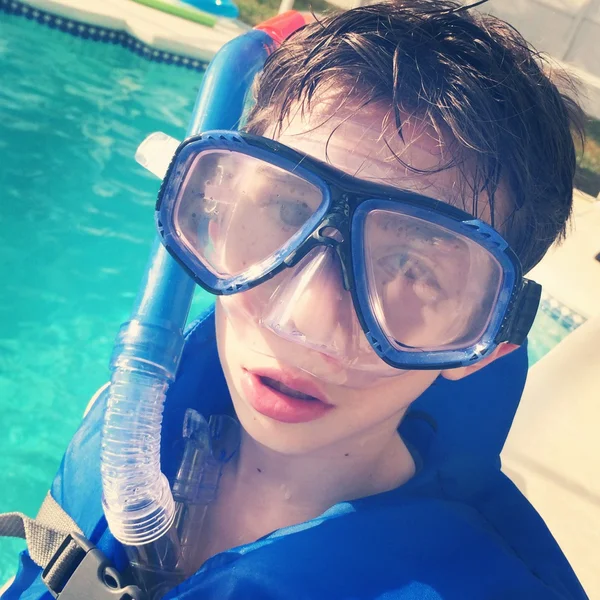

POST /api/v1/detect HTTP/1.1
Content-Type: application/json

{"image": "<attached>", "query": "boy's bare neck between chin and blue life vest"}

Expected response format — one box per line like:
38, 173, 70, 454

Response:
194, 414, 415, 567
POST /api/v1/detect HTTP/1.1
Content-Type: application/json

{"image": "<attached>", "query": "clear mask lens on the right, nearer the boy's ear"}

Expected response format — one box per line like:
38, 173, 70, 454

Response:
364, 209, 502, 351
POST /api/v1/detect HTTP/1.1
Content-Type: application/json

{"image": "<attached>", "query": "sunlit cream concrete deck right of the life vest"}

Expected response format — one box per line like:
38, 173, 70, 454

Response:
502, 314, 600, 598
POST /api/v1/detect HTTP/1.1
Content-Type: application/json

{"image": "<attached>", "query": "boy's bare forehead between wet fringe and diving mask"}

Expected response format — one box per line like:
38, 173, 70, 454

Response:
265, 100, 500, 222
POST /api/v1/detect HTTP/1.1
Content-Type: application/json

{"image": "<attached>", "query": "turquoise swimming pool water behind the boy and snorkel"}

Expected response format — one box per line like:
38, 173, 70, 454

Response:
0, 12, 584, 582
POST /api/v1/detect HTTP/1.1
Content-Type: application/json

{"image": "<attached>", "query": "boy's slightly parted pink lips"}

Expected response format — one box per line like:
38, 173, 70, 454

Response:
242, 369, 333, 423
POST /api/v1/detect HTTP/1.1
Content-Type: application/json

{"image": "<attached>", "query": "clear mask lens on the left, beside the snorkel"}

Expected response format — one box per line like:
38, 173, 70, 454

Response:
175, 150, 323, 280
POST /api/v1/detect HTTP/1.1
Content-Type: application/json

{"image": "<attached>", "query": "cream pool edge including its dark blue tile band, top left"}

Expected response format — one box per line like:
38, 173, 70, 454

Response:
0, 0, 248, 65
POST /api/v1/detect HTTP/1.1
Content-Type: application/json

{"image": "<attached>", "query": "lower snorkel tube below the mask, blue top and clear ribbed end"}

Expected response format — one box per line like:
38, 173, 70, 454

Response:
100, 241, 194, 546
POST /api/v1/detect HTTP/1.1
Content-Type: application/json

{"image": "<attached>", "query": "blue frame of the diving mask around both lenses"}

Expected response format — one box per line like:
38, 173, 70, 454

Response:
156, 131, 541, 369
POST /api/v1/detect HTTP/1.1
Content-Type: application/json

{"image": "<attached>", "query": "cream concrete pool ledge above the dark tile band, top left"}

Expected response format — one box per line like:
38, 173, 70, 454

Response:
6, 0, 248, 62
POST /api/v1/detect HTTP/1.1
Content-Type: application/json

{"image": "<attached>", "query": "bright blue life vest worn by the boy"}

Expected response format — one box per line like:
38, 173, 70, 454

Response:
3, 310, 586, 600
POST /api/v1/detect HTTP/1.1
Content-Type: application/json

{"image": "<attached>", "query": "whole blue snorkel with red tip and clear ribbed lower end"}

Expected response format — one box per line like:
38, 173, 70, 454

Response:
101, 12, 306, 597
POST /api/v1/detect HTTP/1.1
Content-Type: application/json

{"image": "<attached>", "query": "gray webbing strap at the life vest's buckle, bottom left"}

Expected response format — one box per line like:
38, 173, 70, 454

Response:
0, 492, 81, 588
